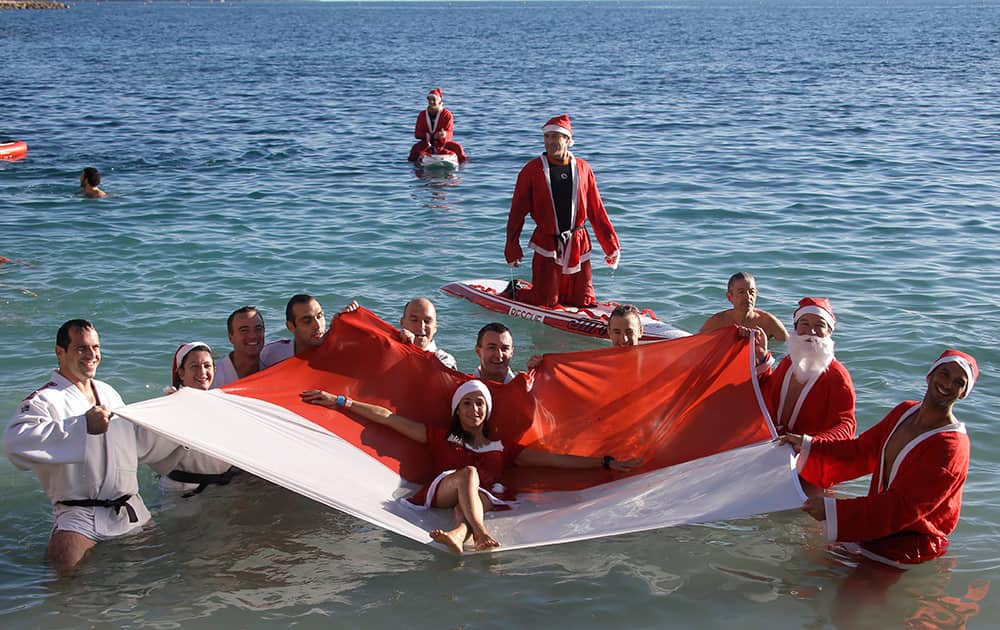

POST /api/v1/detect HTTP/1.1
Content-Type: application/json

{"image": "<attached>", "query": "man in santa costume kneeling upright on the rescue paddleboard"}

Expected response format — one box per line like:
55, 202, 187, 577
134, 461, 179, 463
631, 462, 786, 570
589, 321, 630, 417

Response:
504, 114, 621, 307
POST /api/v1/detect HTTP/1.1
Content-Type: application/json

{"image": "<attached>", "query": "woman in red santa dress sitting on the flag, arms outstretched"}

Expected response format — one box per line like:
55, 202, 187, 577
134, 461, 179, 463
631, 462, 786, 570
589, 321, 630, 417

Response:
302, 379, 638, 553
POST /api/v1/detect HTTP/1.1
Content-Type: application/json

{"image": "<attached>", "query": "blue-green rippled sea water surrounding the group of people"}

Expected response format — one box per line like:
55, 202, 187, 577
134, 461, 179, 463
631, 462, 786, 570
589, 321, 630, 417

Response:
0, 0, 1000, 628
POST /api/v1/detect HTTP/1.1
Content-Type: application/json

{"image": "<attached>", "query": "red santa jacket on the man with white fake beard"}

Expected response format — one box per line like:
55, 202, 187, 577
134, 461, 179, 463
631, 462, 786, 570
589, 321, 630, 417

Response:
759, 356, 857, 439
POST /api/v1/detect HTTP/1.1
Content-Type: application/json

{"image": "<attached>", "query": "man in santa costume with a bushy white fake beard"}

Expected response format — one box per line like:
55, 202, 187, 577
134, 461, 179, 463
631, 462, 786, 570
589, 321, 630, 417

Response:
756, 297, 857, 439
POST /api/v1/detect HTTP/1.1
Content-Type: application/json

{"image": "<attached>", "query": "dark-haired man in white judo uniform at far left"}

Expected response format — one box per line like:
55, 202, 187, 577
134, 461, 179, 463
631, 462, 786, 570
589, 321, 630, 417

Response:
3, 319, 181, 574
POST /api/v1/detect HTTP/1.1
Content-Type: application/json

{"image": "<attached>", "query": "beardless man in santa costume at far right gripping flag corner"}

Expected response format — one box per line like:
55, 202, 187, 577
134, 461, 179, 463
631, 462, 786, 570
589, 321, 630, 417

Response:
782, 350, 979, 569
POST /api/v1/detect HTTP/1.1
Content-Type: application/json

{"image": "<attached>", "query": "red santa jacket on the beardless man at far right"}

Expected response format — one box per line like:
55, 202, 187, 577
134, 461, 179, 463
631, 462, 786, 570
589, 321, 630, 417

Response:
797, 400, 969, 568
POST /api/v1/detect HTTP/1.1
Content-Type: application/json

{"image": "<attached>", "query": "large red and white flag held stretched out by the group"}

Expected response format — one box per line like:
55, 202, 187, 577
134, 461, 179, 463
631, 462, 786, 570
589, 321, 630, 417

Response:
115, 309, 805, 551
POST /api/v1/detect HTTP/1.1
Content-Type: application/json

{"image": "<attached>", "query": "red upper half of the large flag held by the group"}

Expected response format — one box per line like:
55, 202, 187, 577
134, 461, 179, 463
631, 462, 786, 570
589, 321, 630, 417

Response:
229, 309, 771, 490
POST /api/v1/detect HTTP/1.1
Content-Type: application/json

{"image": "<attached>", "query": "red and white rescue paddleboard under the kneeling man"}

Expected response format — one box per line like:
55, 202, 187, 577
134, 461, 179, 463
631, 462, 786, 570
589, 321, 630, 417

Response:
441, 279, 689, 341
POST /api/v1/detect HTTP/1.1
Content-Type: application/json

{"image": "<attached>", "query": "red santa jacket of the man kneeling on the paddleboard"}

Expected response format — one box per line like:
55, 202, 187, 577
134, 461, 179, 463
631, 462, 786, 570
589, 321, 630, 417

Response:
504, 154, 620, 274
